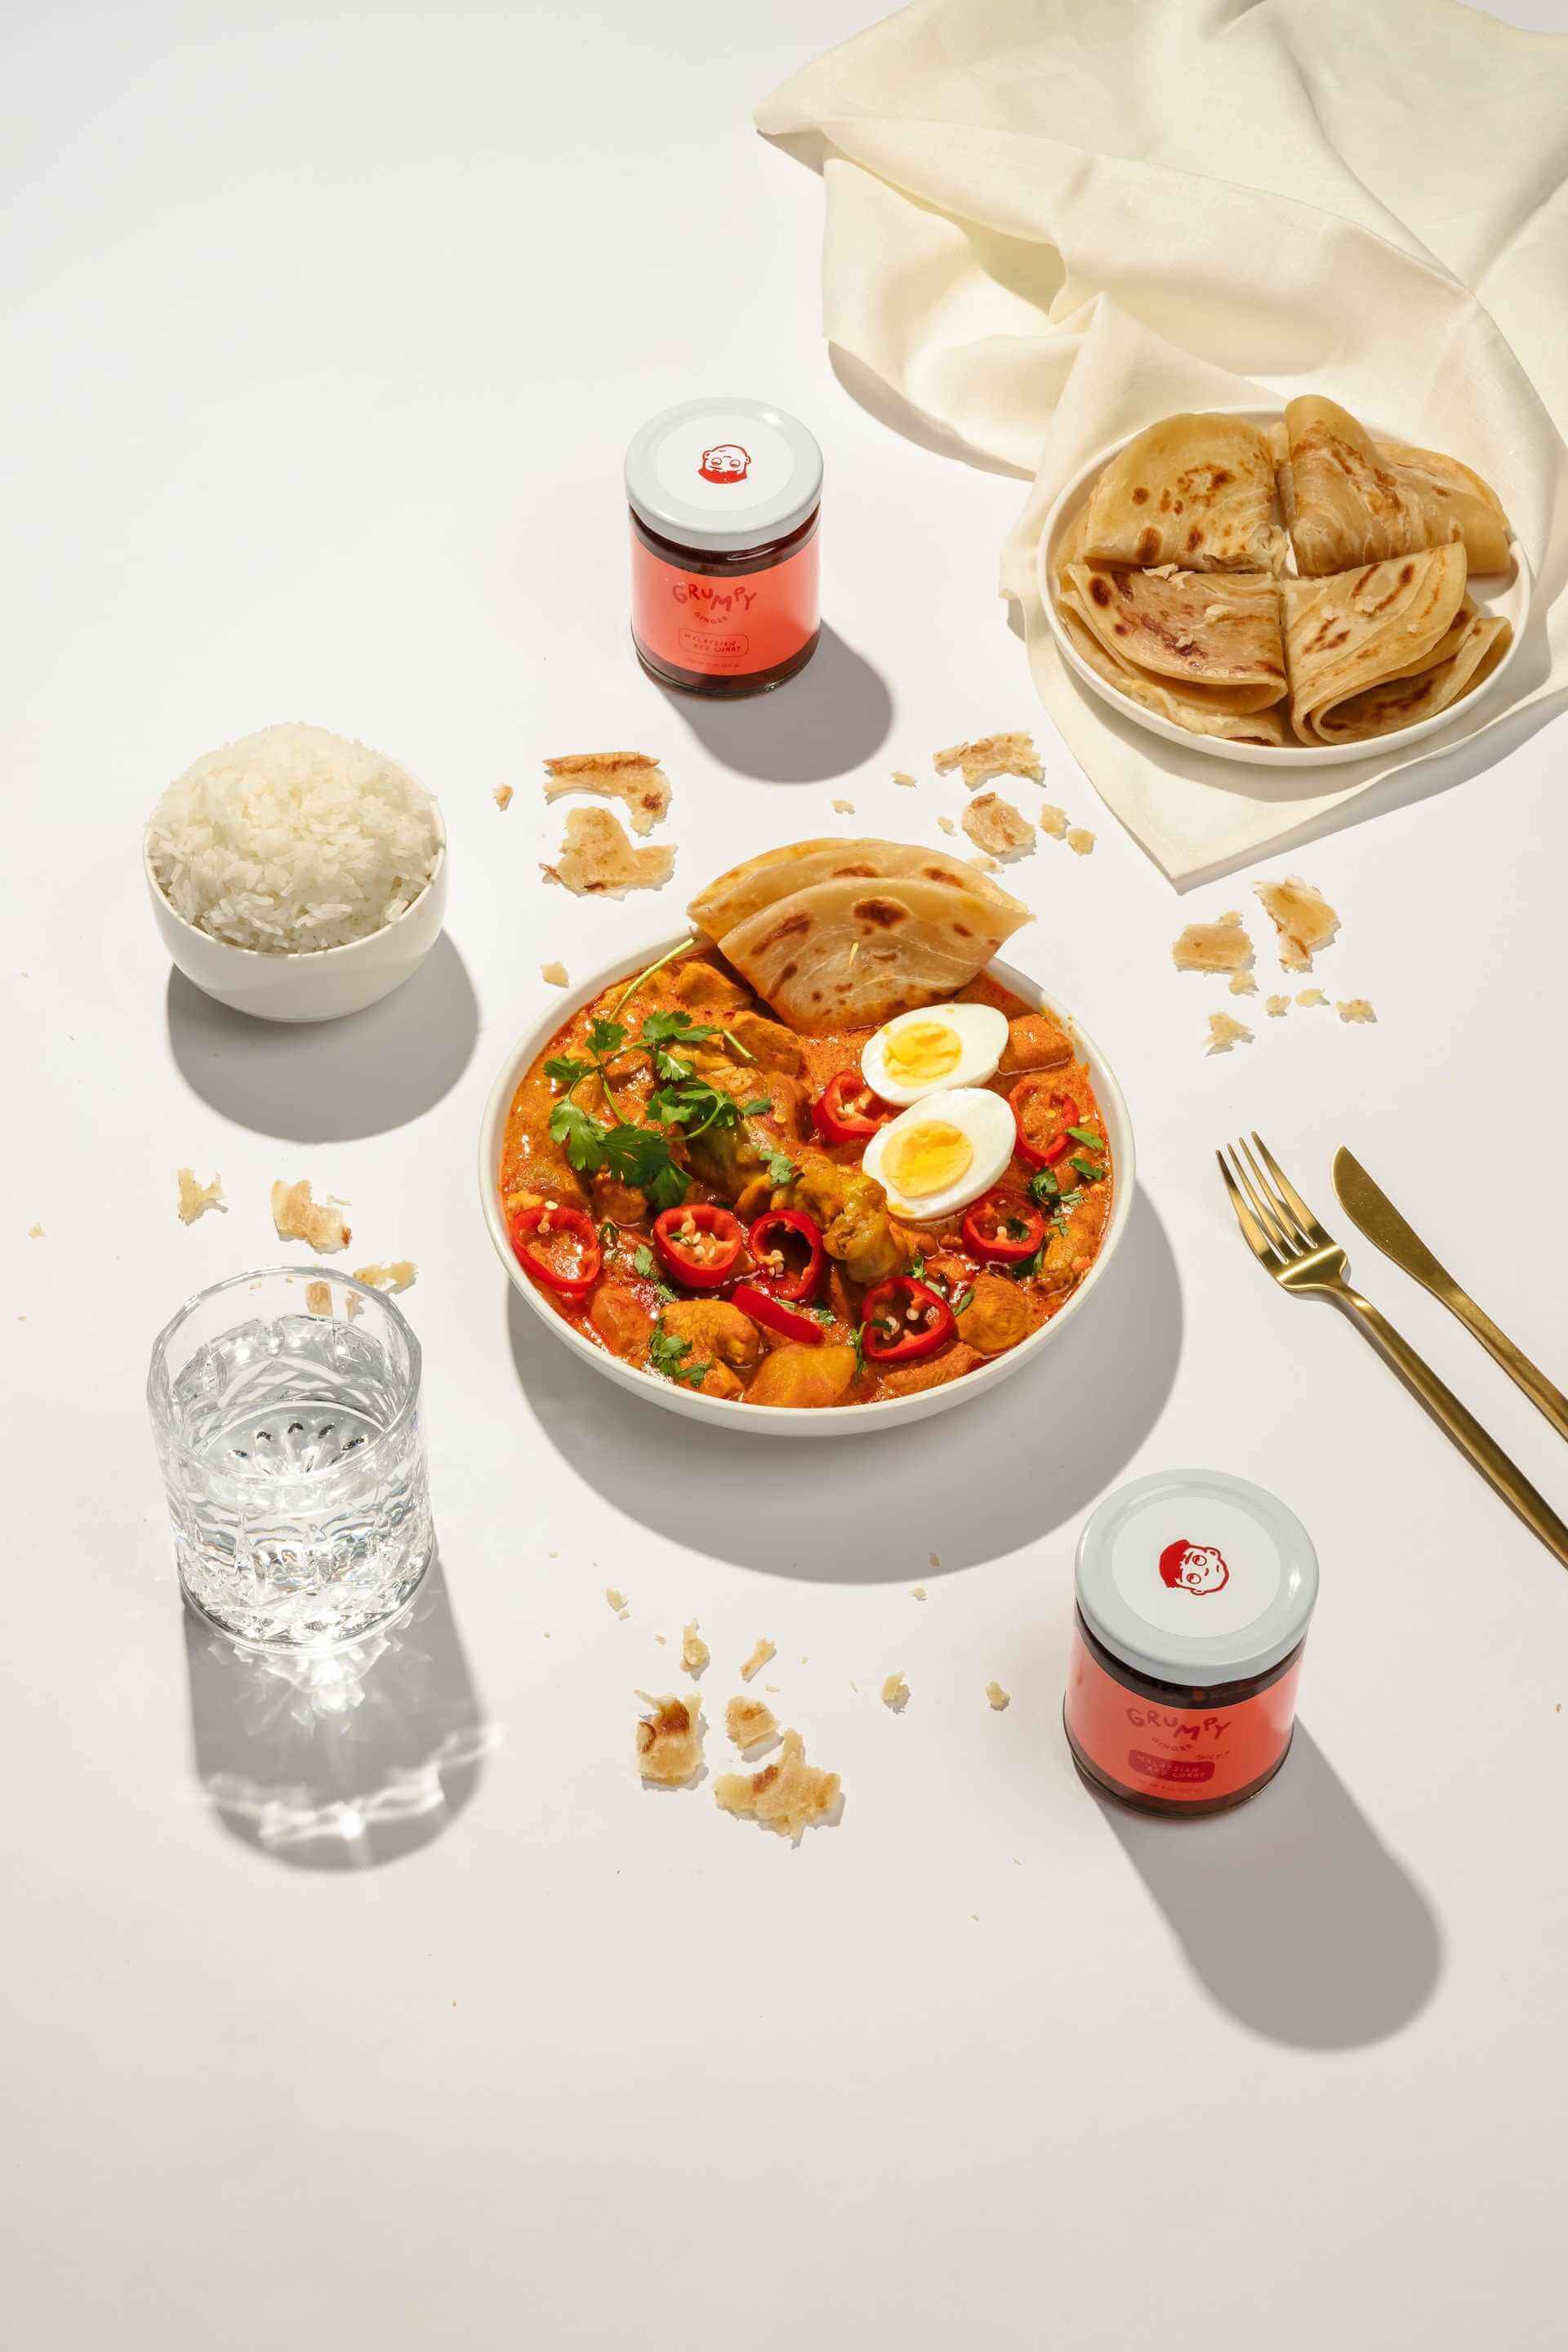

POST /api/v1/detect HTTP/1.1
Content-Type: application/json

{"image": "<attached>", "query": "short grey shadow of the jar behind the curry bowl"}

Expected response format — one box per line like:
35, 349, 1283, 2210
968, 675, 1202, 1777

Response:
661, 623, 893, 783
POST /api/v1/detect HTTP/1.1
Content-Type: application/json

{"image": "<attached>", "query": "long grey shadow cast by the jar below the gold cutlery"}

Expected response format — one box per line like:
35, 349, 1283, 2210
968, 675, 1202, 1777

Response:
1095, 1724, 1443, 2051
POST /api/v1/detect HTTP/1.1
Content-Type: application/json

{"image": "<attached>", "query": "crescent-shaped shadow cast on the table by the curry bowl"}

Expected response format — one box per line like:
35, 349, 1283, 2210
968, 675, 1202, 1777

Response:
508, 1192, 1183, 1585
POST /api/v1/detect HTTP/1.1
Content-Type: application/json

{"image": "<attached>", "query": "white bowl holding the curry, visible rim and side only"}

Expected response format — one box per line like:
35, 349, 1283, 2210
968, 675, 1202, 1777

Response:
479, 938, 1135, 1437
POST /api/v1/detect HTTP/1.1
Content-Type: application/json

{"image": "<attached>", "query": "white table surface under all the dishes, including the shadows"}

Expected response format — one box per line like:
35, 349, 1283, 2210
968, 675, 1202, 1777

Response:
0, 0, 1568, 2352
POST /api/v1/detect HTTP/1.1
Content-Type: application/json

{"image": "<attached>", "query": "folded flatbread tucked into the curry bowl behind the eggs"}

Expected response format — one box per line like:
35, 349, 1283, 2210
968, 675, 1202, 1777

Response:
687, 840, 1030, 1035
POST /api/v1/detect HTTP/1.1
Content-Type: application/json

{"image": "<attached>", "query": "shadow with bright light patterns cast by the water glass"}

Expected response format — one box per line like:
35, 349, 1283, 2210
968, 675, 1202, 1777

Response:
185, 1559, 496, 1870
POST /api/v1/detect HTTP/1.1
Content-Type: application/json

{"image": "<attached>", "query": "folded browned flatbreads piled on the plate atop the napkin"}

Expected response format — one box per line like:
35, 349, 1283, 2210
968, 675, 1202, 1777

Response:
1055, 395, 1512, 746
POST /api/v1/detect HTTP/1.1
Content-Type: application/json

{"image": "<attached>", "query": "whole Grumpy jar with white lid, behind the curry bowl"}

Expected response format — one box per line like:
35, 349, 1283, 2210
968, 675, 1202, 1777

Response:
626, 400, 822, 696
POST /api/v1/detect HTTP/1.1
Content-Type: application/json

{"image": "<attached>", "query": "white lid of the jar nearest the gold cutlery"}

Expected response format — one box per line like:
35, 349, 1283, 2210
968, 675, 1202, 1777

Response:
1076, 1470, 1316, 1686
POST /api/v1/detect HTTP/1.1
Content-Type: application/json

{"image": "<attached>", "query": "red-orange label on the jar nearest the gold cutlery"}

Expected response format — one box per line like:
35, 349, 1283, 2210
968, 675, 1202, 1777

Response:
1067, 1625, 1303, 1804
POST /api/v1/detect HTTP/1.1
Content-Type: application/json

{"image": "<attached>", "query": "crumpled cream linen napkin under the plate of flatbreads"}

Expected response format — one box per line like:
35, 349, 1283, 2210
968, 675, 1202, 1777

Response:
757, 0, 1568, 882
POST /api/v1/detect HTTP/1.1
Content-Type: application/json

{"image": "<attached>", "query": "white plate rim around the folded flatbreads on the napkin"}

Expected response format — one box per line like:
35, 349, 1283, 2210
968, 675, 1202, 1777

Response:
1035, 407, 1535, 767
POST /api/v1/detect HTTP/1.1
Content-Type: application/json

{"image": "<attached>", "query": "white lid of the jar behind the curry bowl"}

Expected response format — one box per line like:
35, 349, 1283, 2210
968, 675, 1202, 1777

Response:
626, 400, 822, 555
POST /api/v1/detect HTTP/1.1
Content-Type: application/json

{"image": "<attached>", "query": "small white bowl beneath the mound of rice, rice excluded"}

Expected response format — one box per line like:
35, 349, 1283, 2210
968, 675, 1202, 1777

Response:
141, 812, 447, 1021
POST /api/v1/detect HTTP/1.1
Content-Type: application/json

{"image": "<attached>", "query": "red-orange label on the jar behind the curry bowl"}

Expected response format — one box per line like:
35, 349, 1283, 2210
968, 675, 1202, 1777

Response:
632, 532, 818, 677
